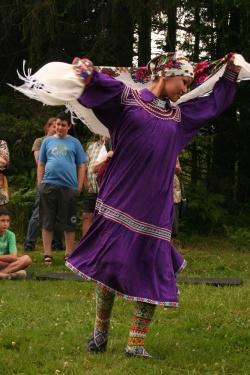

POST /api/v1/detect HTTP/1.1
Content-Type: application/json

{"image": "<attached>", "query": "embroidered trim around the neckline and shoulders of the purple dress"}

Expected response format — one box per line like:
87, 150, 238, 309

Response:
121, 86, 181, 122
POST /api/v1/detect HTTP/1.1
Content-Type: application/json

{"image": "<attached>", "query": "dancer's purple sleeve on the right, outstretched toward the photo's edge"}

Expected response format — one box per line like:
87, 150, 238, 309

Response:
179, 69, 238, 149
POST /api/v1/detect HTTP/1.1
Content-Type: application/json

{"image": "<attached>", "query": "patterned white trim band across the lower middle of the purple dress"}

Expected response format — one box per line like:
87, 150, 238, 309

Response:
96, 199, 171, 242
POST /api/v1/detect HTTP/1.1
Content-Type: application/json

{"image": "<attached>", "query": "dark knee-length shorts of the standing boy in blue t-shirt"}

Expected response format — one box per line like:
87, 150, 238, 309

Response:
39, 183, 78, 232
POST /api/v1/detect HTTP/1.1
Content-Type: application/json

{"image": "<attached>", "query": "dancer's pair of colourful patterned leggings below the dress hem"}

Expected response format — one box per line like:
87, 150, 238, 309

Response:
95, 285, 155, 349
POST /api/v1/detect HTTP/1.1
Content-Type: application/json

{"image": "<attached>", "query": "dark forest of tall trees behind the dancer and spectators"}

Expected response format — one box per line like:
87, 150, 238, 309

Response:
0, 0, 250, 250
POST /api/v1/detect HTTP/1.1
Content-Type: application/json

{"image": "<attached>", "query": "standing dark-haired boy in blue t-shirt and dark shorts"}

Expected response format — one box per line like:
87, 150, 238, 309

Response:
37, 112, 87, 264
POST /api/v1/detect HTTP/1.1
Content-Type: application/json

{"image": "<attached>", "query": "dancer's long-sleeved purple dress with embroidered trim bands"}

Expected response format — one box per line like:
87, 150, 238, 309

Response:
67, 69, 237, 306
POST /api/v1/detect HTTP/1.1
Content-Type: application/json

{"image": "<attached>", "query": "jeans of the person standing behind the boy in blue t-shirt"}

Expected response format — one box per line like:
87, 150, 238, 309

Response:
24, 190, 63, 249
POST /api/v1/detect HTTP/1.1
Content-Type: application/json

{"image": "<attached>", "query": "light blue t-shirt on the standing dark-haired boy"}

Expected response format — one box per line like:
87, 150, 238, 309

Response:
38, 135, 87, 189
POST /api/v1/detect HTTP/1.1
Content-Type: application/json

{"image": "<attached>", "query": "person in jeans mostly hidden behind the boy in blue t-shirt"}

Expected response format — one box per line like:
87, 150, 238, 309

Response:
24, 117, 63, 251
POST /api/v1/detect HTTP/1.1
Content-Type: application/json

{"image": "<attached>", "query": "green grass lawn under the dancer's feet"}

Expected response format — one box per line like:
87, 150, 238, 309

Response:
0, 237, 250, 375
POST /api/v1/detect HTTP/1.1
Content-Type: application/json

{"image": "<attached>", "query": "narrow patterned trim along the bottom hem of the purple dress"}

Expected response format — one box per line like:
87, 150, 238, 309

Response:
65, 262, 187, 307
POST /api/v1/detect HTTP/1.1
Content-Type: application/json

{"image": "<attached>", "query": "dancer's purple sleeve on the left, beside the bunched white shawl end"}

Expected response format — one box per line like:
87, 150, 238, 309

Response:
78, 71, 125, 130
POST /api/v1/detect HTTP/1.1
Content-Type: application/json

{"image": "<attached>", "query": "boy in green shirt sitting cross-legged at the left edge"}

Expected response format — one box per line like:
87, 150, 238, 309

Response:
0, 207, 32, 279
